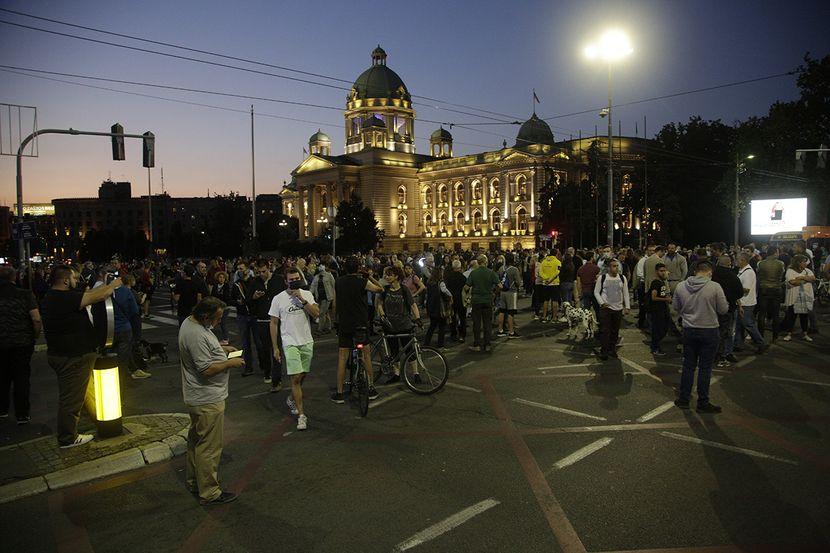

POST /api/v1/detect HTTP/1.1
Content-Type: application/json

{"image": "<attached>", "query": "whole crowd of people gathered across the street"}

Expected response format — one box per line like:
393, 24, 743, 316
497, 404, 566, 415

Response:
0, 237, 830, 504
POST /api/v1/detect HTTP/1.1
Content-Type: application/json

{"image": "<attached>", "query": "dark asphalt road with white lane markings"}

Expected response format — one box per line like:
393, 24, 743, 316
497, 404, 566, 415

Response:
0, 288, 830, 552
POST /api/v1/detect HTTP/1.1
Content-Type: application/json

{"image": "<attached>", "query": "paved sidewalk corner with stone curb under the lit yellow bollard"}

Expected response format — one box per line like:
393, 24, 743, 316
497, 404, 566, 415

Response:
0, 413, 190, 503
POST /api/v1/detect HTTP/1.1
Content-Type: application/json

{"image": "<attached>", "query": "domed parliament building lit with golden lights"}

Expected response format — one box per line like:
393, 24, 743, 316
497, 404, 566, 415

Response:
281, 46, 638, 251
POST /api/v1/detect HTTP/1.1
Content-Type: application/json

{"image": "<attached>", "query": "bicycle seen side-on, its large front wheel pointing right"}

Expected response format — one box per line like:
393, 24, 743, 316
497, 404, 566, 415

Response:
372, 325, 450, 395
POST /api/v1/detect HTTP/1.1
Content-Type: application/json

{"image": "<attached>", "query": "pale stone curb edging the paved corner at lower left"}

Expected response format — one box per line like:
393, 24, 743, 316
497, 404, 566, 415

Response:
0, 413, 189, 504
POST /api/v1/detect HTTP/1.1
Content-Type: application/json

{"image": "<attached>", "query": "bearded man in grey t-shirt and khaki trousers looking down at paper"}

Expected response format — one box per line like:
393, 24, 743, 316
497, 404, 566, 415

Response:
179, 297, 245, 505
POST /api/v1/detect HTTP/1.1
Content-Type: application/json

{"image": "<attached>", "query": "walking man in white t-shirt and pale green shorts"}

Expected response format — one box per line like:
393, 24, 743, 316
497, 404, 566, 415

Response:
268, 267, 320, 430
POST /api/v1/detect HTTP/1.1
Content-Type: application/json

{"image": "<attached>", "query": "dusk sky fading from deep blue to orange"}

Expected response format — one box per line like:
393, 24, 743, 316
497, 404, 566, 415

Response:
0, 0, 830, 205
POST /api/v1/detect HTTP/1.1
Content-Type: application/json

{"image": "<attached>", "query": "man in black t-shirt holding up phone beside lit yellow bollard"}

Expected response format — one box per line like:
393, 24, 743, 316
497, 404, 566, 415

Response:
41, 265, 121, 448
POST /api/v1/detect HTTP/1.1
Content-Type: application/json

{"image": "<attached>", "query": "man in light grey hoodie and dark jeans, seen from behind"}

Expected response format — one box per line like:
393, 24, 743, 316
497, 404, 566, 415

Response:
672, 261, 729, 413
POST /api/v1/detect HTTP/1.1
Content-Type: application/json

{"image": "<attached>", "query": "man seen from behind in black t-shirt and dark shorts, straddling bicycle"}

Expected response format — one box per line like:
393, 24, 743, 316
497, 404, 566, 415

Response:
331, 257, 383, 403
